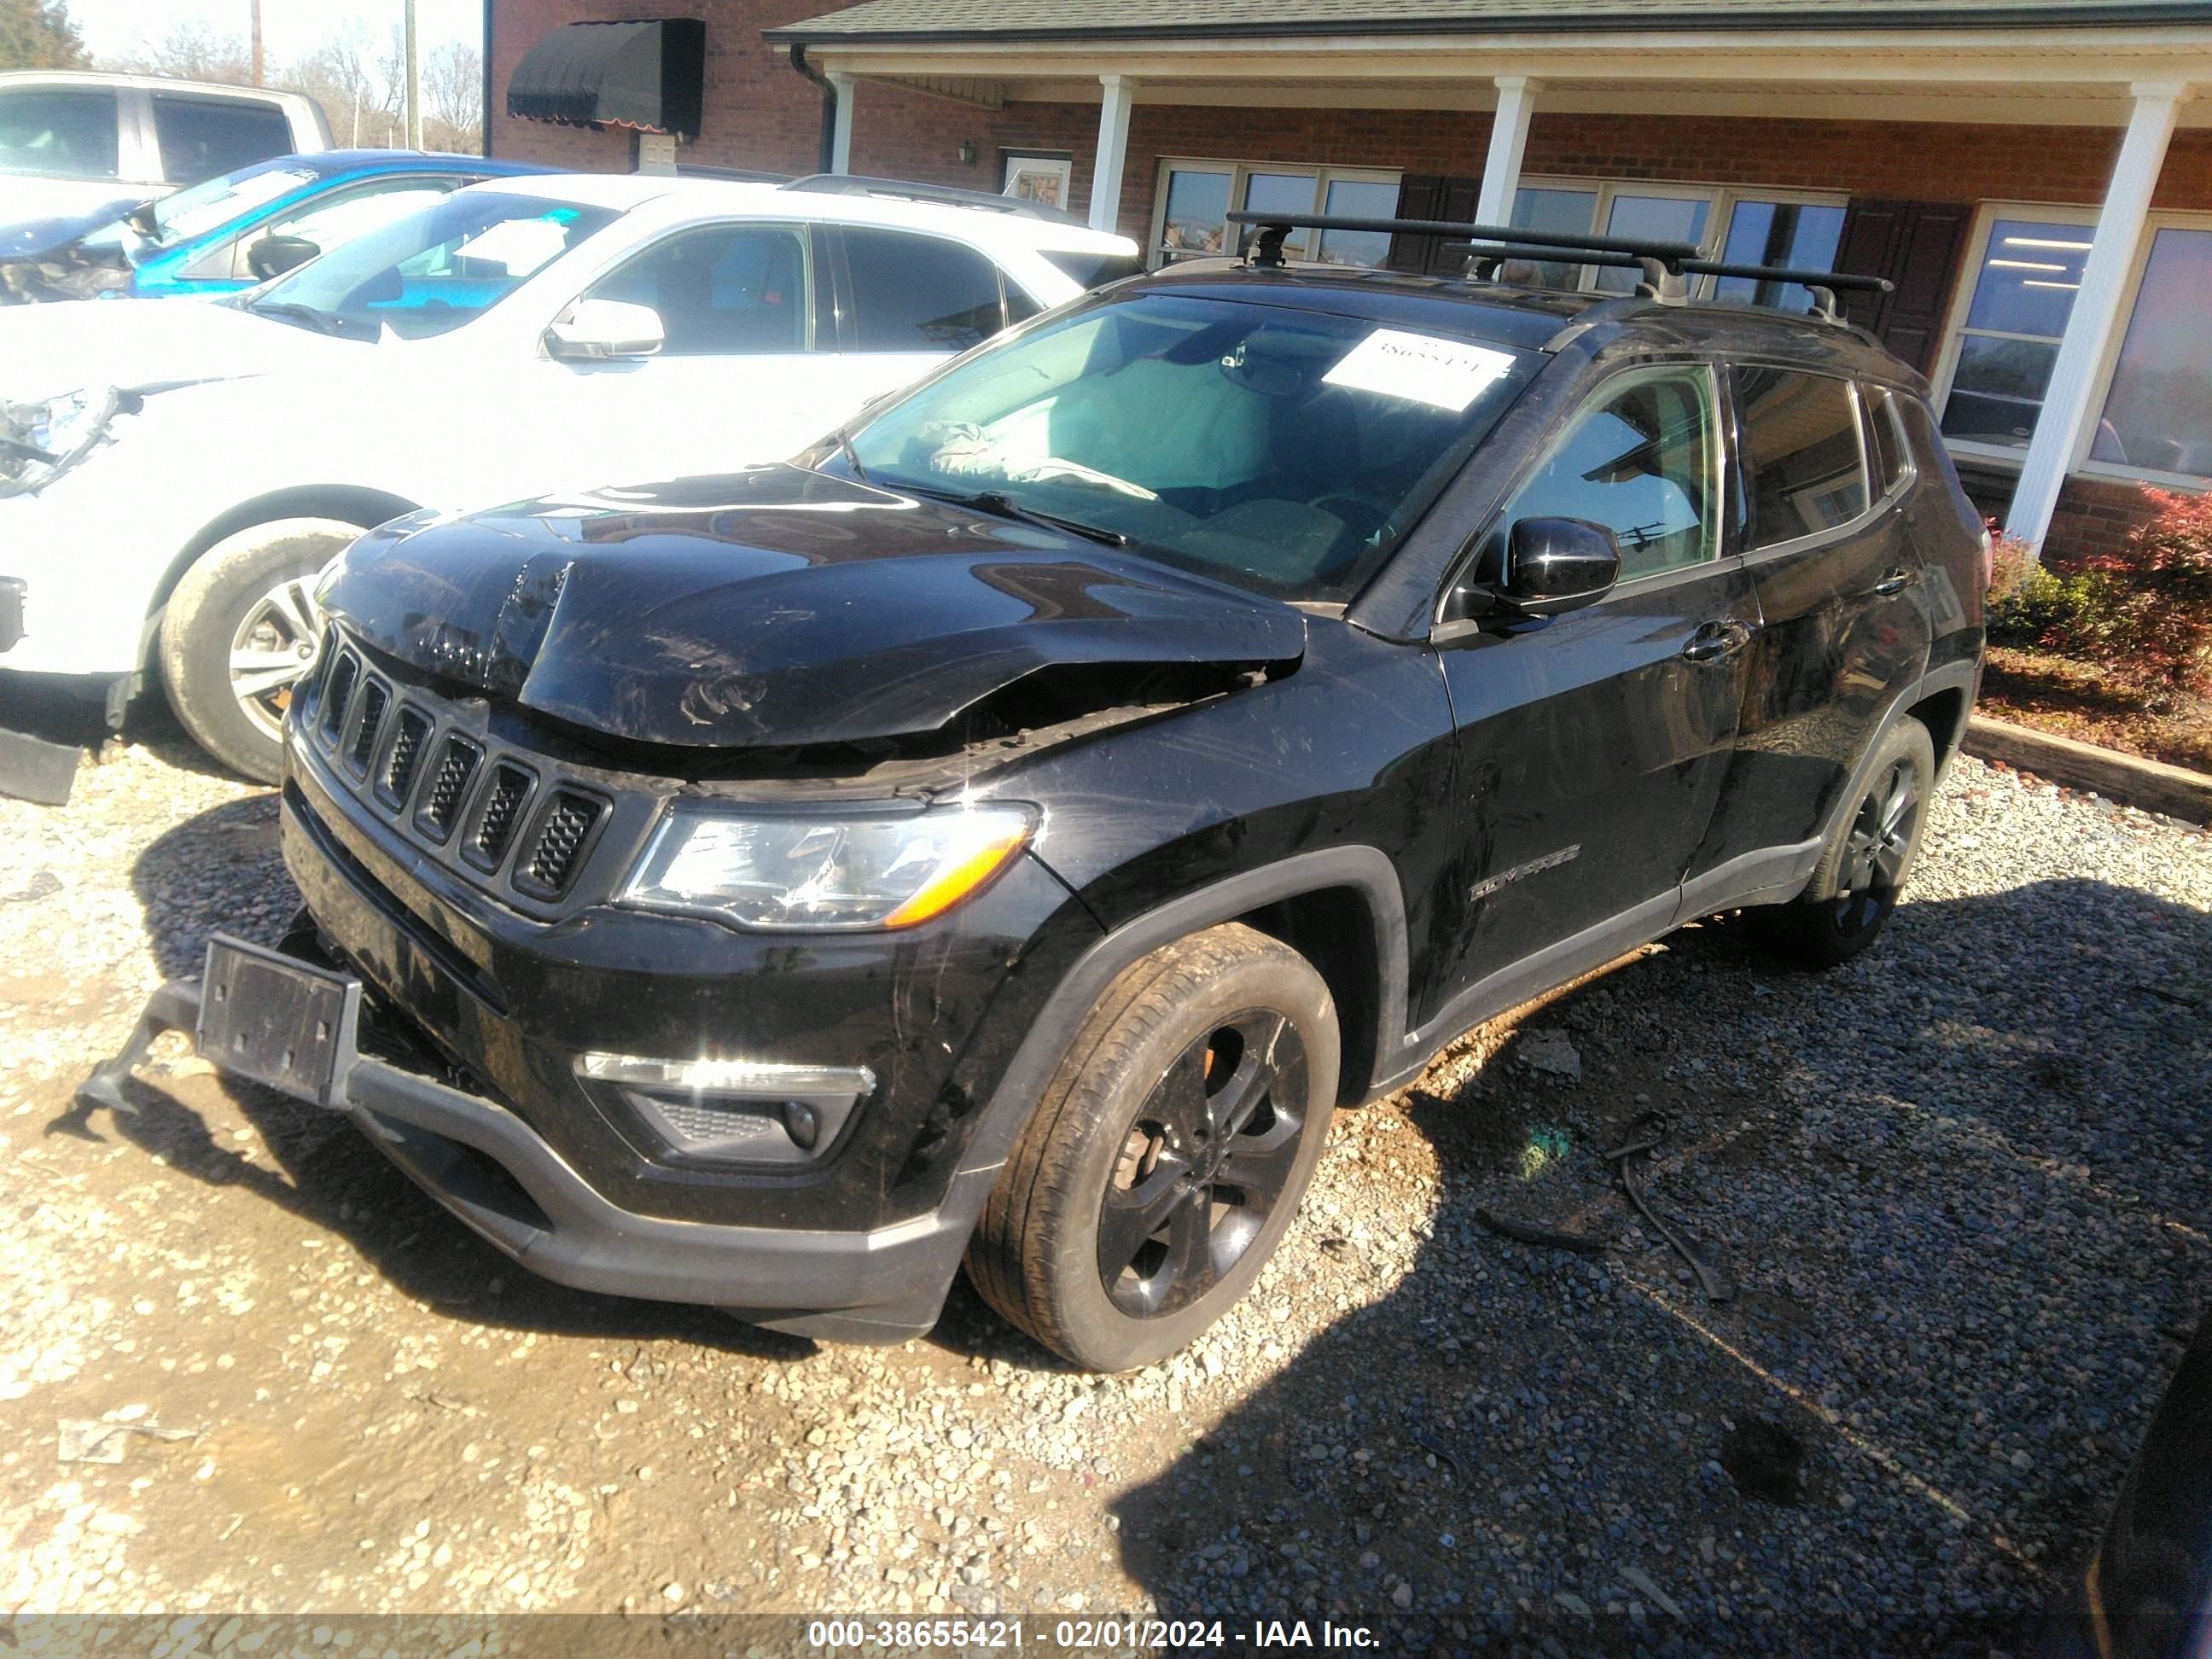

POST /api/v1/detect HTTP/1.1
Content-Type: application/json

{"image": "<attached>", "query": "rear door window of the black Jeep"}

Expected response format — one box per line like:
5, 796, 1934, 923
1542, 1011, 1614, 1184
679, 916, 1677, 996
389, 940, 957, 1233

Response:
1737, 367, 1869, 549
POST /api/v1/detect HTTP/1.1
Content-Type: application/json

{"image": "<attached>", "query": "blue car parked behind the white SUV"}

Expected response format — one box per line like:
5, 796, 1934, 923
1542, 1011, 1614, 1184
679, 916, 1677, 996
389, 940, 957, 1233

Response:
0, 150, 550, 306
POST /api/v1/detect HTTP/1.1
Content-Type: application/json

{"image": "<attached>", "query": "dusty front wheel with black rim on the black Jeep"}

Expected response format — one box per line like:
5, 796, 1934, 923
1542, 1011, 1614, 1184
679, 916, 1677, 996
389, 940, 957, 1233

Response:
967, 924, 1341, 1371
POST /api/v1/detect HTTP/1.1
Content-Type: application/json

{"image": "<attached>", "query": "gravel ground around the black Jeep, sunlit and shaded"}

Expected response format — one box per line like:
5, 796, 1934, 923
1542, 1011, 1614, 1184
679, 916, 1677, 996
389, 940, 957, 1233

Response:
0, 743, 2212, 1655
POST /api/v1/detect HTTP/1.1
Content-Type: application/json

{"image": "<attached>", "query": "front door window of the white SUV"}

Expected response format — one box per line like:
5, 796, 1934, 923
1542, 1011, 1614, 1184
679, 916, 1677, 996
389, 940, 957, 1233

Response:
588, 225, 814, 356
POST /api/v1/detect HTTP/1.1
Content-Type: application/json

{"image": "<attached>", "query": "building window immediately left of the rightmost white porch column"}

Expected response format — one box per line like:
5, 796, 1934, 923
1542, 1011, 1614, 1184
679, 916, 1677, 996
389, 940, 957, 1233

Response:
1942, 217, 2093, 449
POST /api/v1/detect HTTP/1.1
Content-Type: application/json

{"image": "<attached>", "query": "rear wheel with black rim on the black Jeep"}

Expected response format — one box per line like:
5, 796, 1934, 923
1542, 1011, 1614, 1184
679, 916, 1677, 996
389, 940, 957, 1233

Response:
1752, 719, 1936, 971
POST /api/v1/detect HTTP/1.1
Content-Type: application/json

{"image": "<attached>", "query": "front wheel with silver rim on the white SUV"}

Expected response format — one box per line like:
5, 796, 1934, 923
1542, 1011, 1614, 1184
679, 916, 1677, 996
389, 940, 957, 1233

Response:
161, 518, 360, 783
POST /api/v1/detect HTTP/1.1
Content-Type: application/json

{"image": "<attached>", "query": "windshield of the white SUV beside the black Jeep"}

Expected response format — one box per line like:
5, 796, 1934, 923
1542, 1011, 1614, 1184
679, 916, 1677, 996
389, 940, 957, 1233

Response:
247, 190, 615, 341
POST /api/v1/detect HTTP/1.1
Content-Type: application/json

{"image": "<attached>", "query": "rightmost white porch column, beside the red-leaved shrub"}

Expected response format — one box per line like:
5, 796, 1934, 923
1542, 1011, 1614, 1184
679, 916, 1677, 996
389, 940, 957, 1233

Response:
2004, 82, 2190, 550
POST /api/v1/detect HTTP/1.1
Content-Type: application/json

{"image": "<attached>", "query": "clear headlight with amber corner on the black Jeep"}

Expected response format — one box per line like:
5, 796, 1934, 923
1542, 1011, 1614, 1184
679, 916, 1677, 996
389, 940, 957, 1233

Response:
621, 805, 1035, 929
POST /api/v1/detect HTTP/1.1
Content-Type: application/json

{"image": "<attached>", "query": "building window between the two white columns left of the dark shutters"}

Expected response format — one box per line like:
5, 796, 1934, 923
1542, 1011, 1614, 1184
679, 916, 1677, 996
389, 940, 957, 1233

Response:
1152, 161, 1398, 265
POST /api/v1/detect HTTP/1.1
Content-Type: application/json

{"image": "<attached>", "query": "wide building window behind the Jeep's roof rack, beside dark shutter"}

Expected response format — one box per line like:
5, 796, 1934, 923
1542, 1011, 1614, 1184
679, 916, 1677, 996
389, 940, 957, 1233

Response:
1513, 179, 1845, 311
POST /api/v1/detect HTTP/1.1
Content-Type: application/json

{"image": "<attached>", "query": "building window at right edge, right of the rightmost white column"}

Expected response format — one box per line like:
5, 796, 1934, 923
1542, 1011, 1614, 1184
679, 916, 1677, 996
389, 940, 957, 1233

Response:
2088, 225, 2212, 478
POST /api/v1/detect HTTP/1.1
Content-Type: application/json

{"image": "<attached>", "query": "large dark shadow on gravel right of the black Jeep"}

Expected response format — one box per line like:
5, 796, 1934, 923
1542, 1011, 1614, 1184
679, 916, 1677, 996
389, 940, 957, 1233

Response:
1115, 881, 2212, 1659
